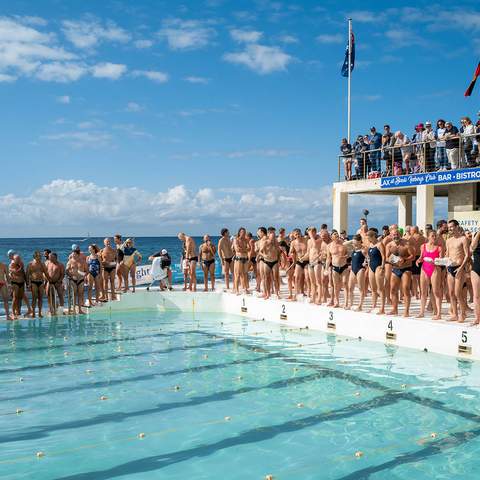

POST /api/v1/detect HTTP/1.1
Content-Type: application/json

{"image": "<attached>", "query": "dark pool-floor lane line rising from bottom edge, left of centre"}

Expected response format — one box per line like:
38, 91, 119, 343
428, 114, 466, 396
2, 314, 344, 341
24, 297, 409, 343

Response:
49, 394, 397, 480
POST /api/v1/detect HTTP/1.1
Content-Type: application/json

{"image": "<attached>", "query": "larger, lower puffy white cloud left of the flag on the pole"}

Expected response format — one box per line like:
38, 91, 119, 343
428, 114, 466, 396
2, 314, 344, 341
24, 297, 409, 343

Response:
223, 44, 293, 75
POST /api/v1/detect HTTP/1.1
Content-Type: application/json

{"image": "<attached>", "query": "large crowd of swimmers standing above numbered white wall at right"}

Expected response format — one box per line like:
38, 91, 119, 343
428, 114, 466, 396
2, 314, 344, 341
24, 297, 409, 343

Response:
178, 218, 480, 325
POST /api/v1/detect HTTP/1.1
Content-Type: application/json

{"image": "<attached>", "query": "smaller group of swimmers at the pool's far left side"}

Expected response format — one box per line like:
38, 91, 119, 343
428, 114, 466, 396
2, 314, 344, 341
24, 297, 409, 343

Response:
0, 235, 171, 320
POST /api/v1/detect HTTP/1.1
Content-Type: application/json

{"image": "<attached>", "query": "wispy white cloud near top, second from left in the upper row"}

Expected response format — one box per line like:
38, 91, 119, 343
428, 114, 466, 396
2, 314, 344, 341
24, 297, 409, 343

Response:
63, 19, 130, 48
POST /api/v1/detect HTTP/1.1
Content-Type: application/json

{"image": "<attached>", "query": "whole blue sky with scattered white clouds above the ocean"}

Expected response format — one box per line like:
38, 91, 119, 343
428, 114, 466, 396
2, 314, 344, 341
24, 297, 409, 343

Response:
0, 0, 480, 237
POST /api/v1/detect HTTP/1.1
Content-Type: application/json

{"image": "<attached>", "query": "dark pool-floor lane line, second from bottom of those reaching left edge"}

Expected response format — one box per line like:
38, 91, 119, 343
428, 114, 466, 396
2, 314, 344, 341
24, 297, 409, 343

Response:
0, 353, 278, 402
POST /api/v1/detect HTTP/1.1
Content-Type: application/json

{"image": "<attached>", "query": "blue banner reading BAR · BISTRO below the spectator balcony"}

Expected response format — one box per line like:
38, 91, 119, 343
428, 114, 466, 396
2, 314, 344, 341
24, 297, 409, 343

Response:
380, 167, 480, 188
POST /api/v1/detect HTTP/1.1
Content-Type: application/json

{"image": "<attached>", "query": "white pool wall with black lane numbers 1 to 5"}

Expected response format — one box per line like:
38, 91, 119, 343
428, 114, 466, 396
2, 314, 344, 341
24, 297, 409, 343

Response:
92, 289, 480, 360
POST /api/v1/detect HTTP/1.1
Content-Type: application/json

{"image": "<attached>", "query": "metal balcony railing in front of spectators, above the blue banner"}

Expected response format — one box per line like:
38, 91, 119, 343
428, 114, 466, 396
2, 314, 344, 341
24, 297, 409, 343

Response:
338, 133, 480, 182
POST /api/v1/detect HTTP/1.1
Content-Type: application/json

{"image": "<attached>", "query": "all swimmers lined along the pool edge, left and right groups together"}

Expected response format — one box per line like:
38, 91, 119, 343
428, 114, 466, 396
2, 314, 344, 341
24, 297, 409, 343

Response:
0, 225, 480, 325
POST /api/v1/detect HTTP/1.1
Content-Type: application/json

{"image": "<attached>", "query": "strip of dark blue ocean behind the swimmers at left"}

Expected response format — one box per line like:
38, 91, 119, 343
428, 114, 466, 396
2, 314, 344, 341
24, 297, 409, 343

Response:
0, 237, 221, 283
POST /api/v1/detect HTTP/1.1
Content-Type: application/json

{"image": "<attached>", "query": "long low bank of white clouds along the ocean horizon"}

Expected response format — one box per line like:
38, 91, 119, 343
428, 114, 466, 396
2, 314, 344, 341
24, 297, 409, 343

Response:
0, 179, 404, 235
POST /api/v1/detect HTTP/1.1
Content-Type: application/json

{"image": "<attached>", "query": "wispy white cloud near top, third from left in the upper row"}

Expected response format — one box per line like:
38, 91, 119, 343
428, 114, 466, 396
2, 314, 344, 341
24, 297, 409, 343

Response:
158, 18, 215, 50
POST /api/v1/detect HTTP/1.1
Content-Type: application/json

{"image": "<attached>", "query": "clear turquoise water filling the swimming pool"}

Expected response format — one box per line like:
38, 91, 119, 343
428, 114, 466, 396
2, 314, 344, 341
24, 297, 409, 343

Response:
0, 312, 480, 480
